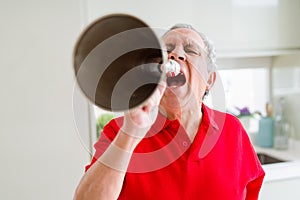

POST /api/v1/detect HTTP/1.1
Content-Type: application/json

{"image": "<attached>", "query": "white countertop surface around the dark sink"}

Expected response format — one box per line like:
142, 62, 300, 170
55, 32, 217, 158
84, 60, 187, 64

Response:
254, 140, 300, 182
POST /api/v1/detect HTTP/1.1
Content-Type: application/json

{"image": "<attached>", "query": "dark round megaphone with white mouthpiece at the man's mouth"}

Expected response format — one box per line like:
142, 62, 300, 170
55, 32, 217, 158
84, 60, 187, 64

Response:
73, 14, 180, 112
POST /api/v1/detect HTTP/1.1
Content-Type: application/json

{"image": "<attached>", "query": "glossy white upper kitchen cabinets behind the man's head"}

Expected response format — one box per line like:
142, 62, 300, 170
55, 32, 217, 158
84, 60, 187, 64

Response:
85, 0, 300, 55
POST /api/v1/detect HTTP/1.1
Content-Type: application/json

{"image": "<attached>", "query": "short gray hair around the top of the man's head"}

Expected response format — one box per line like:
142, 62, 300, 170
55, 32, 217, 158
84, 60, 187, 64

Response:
165, 23, 217, 72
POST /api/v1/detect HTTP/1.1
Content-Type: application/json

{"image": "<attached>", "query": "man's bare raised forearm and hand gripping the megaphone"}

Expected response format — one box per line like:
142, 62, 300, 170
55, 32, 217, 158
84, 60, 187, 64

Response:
74, 82, 166, 200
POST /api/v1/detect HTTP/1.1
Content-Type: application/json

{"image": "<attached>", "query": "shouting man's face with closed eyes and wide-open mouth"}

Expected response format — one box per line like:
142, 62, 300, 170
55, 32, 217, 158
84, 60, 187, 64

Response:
163, 28, 210, 107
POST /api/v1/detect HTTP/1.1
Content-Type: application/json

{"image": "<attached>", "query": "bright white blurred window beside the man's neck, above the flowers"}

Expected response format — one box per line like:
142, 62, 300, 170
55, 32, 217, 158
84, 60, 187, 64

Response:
219, 68, 270, 133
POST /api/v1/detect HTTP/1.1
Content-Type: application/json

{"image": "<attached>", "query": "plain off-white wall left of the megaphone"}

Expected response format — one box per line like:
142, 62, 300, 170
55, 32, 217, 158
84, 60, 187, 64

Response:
0, 0, 89, 200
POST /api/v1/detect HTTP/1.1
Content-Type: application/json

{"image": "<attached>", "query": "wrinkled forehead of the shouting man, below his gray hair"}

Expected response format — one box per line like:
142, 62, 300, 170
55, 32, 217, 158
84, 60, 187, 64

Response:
163, 28, 207, 50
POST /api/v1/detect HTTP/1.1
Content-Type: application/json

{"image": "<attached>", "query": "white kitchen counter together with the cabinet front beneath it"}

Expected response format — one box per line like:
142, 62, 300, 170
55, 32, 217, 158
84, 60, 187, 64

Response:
254, 140, 300, 200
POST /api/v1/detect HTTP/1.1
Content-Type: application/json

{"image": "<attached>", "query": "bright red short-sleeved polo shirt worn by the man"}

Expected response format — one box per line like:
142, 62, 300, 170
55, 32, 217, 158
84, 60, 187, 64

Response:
86, 104, 265, 200
